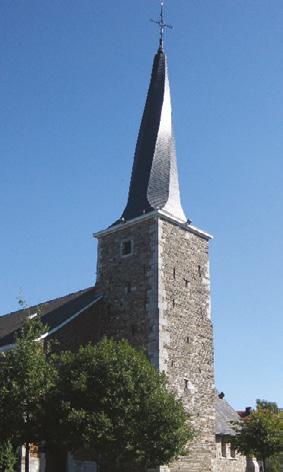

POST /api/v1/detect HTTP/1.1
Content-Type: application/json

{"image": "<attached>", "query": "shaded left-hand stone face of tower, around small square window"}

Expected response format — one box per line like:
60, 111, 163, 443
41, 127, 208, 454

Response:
96, 218, 158, 366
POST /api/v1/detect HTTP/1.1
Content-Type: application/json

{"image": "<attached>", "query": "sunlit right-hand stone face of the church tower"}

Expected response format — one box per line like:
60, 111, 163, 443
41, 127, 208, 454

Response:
159, 220, 215, 472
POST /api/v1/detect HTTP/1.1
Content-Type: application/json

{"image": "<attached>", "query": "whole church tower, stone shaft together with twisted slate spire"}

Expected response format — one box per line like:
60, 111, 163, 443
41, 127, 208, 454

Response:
95, 43, 215, 472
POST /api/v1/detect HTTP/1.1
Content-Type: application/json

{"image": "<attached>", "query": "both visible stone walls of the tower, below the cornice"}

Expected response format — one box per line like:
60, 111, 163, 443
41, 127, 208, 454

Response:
93, 215, 215, 472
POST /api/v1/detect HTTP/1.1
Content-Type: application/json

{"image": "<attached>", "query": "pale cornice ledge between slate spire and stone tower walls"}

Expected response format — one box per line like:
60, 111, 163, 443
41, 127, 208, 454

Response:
93, 214, 213, 241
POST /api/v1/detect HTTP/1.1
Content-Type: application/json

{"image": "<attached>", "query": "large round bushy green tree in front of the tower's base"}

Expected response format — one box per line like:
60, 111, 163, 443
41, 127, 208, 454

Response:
46, 339, 192, 472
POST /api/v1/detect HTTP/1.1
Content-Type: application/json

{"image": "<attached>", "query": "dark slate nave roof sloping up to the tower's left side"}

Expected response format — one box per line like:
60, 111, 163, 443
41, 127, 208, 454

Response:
0, 287, 100, 348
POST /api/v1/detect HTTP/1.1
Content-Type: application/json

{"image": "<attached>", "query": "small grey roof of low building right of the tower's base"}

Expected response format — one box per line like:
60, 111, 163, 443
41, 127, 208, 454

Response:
215, 395, 240, 436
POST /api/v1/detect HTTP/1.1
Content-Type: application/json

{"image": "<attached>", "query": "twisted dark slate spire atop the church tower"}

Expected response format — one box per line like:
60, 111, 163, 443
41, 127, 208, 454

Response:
122, 47, 186, 222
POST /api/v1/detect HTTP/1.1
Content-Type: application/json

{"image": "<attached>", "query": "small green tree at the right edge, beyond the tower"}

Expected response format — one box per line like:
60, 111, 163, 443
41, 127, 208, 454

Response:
234, 400, 283, 471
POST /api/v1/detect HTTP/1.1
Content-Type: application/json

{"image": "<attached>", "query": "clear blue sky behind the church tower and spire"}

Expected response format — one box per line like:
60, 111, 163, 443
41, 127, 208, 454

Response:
0, 0, 283, 408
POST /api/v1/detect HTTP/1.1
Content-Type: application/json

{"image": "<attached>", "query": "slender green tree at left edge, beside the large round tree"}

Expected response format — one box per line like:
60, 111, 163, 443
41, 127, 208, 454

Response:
0, 318, 54, 472
